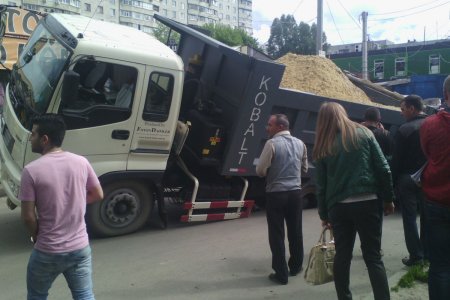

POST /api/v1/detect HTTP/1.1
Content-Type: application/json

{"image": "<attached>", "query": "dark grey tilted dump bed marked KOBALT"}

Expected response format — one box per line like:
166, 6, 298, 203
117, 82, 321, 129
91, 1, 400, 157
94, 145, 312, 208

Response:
155, 15, 403, 176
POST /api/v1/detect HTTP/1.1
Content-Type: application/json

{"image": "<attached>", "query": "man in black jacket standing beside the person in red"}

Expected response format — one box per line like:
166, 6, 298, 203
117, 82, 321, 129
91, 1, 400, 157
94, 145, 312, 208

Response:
391, 95, 426, 266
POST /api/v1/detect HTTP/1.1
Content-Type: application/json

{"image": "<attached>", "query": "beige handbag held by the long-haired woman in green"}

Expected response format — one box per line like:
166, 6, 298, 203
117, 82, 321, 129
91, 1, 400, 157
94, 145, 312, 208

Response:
305, 228, 336, 285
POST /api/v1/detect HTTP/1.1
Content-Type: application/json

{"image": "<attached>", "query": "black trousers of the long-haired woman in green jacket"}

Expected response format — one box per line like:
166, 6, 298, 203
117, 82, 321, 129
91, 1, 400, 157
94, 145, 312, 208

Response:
328, 200, 390, 300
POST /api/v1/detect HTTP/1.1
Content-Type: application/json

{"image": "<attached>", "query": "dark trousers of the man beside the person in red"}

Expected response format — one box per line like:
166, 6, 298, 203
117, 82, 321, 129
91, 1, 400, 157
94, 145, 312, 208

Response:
397, 174, 427, 260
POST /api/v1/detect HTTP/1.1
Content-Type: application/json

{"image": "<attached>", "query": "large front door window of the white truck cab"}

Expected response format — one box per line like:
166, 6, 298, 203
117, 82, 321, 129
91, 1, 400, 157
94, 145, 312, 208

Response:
60, 59, 137, 129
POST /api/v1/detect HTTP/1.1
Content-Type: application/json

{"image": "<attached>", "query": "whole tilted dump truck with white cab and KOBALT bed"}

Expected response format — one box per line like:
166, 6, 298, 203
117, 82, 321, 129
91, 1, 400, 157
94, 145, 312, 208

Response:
0, 14, 402, 236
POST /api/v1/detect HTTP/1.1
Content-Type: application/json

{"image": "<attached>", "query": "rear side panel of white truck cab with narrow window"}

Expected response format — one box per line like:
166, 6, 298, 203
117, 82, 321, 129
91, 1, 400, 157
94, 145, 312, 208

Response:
127, 66, 181, 170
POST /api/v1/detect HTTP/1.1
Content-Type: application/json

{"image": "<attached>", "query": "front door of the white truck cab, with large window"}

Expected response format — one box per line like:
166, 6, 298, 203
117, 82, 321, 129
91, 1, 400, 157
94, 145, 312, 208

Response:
55, 57, 145, 174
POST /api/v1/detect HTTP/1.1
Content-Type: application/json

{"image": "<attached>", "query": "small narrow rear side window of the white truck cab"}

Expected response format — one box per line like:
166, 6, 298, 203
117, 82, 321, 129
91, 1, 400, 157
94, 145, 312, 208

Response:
142, 72, 173, 122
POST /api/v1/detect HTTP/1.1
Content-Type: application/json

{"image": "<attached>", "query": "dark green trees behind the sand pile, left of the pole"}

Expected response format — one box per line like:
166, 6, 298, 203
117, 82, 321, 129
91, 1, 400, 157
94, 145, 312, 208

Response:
267, 15, 329, 58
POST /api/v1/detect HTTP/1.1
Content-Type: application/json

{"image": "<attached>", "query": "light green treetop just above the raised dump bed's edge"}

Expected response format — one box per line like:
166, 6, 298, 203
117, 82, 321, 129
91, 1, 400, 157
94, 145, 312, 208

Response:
202, 24, 260, 49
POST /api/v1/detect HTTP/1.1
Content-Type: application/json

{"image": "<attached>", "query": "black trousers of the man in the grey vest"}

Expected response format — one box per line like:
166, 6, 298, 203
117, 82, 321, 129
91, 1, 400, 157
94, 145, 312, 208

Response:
266, 190, 303, 282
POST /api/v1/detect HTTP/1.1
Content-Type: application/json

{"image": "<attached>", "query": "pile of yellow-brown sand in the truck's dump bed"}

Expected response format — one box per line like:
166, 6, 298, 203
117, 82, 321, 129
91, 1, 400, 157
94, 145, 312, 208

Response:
277, 53, 383, 106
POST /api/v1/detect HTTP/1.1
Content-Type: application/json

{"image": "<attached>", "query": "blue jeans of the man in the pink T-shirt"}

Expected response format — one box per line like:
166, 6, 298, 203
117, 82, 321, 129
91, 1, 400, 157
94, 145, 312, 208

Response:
27, 246, 95, 300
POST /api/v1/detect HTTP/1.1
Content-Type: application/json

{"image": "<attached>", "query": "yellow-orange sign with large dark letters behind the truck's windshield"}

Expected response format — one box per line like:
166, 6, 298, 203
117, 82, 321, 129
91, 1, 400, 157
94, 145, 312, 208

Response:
0, 7, 41, 69
